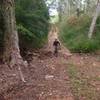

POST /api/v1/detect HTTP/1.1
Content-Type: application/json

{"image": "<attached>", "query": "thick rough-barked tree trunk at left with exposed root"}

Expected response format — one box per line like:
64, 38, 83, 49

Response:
1, 0, 25, 81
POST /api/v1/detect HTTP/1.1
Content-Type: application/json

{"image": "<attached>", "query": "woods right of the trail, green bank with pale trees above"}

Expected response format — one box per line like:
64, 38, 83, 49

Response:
59, 0, 100, 53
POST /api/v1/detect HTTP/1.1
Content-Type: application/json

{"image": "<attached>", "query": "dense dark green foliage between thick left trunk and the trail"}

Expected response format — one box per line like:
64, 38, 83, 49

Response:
16, 0, 49, 48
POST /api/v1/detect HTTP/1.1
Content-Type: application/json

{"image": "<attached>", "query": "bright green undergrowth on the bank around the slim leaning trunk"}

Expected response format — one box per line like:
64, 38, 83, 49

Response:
60, 16, 100, 53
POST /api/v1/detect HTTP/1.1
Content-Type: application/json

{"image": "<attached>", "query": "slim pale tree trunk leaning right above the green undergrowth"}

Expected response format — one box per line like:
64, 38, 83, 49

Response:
88, 2, 100, 39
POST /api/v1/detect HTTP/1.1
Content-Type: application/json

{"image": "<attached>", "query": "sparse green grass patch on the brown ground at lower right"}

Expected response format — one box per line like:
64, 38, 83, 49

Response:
68, 64, 100, 100
